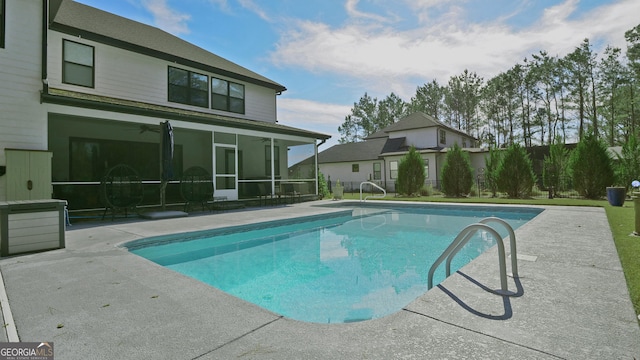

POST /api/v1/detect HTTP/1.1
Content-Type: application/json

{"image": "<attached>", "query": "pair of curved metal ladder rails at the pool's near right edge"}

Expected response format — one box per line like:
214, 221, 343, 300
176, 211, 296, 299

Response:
428, 217, 518, 295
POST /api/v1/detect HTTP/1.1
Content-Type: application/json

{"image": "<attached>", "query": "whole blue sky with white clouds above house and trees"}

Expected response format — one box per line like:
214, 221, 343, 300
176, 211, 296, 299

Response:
76, 0, 640, 148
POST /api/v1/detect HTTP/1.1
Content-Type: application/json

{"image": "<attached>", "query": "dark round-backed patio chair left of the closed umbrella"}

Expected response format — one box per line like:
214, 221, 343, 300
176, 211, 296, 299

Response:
100, 164, 144, 220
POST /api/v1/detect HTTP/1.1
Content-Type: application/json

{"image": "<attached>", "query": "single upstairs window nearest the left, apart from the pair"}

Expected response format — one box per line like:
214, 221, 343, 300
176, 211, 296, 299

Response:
63, 40, 94, 87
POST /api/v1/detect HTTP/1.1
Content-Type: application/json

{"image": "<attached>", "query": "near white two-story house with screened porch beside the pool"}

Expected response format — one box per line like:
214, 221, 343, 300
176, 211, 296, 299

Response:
0, 0, 329, 210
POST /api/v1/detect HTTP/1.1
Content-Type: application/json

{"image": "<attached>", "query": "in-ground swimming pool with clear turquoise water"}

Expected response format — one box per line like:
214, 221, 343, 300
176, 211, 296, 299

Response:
125, 205, 542, 323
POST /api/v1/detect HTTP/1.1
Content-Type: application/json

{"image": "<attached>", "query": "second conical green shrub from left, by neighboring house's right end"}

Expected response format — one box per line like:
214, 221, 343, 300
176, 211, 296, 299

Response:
442, 143, 473, 197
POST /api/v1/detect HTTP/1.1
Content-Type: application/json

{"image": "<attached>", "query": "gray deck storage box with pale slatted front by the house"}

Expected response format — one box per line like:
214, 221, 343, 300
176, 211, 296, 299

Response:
0, 199, 65, 256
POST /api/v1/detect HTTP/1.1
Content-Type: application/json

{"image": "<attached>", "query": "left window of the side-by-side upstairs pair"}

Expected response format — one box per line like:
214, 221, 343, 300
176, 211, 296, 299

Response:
169, 66, 209, 107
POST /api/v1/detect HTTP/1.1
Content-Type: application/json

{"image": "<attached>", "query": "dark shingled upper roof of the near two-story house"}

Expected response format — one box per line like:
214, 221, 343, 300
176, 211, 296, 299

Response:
49, 0, 287, 92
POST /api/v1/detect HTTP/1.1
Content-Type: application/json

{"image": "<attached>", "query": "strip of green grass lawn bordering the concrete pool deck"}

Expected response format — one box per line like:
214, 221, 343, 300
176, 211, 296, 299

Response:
344, 193, 640, 315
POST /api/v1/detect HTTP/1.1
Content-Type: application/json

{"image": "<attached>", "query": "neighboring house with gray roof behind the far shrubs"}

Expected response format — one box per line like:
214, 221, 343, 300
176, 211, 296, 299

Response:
308, 112, 485, 192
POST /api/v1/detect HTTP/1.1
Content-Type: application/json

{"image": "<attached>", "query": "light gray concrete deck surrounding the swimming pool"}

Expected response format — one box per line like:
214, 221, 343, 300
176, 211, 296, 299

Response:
0, 201, 640, 359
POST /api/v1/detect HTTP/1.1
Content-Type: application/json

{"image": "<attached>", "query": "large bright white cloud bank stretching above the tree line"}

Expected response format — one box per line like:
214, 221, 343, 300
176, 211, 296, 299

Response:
271, 0, 640, 98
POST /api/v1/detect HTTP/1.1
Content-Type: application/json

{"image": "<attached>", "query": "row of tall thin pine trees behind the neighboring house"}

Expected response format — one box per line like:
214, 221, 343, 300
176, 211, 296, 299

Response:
338, 24, 640, 147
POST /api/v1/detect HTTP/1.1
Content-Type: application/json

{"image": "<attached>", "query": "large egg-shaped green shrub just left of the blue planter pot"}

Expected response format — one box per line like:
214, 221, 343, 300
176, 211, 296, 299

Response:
570, 135, 615, 199
